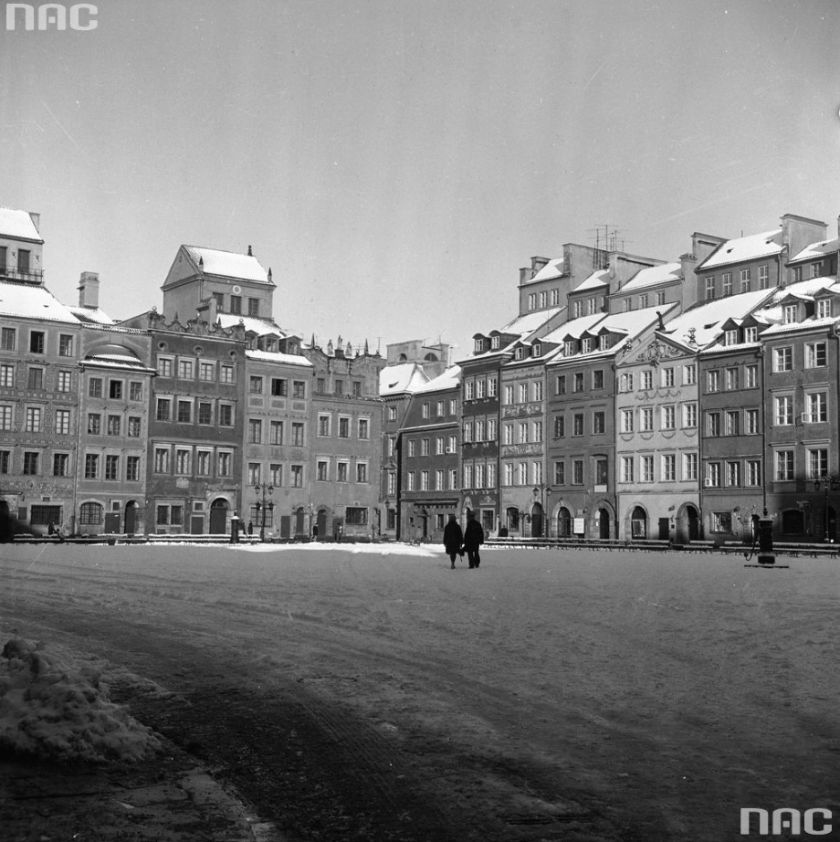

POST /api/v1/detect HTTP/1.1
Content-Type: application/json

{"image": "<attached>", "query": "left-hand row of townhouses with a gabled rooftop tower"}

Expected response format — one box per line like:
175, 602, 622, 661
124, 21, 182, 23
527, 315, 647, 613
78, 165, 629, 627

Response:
0, 209, 394, 537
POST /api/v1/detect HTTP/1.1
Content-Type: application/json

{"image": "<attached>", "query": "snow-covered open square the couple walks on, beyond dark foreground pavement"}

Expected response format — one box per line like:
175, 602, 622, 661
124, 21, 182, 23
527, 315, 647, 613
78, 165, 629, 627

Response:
0, 544, 840, 841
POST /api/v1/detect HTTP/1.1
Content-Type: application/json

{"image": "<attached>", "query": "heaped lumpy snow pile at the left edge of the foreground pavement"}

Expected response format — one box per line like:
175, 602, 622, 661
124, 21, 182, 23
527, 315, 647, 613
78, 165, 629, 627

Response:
0, 637, 161, 761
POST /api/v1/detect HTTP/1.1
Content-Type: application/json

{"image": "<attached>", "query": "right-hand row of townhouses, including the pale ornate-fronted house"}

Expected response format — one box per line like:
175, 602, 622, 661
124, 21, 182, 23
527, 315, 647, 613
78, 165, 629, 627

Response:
400, 214, 840, 543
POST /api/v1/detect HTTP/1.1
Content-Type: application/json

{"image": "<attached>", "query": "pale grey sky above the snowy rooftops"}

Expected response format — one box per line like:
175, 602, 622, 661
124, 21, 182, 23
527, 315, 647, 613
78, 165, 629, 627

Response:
0, 0, 840, 356
